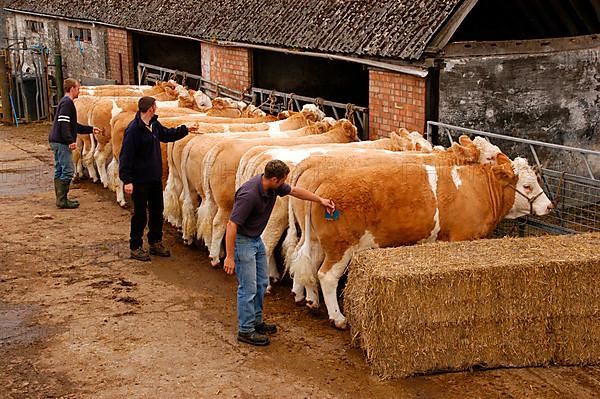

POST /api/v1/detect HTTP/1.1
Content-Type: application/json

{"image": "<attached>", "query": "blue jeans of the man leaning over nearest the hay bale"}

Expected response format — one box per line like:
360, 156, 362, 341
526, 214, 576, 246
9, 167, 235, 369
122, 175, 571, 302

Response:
234, 234, 269, 333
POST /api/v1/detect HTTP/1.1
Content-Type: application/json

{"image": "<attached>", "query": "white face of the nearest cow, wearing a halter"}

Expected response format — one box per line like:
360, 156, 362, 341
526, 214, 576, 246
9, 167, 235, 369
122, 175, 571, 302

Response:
506, 158, 554, 219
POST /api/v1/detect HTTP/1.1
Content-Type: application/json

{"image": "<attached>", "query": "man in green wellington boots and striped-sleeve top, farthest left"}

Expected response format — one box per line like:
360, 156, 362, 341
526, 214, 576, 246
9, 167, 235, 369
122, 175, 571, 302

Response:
48, 78, 100, 209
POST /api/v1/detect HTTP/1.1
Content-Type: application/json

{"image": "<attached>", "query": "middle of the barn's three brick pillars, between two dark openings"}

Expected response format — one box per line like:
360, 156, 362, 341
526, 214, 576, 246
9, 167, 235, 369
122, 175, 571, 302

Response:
200, 43, 252, 90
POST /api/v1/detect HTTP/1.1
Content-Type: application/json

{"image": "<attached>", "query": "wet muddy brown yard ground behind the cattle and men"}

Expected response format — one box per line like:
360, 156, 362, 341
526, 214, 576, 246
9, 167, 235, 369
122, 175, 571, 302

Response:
0, 124, 600, 398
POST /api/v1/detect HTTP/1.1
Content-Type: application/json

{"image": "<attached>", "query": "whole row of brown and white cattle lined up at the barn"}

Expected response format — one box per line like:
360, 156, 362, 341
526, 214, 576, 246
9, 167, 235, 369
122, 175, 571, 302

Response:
74, 82, 553, 328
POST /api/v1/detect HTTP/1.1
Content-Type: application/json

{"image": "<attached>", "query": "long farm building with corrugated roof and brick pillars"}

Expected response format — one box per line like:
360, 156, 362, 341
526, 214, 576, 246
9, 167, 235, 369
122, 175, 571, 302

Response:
5, 0, 600, 147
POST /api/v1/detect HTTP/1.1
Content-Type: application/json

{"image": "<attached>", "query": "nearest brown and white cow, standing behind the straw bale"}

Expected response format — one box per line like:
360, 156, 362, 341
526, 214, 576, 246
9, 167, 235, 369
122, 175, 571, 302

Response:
294, 154, 553, 328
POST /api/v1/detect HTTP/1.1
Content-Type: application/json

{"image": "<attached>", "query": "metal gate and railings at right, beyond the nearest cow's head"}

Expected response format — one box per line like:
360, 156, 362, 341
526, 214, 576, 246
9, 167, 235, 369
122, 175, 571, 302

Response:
427, 122, 600, 236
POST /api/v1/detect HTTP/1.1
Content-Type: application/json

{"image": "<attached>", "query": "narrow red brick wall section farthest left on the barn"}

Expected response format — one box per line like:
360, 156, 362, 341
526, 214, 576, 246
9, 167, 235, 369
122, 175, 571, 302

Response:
106, 28, 135, 84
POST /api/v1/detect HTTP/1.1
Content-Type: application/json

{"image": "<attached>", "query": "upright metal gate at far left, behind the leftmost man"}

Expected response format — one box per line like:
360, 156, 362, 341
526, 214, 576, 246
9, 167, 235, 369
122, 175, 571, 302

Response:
2, 39, 51, 124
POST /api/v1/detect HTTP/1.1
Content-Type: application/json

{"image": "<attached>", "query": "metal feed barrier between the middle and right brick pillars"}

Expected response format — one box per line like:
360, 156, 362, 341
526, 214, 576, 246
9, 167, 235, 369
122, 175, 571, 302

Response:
252, 87, 369, 140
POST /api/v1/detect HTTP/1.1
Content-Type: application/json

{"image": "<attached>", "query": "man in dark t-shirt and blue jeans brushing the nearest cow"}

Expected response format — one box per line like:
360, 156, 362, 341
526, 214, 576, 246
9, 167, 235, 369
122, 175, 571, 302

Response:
223, 160, 335, 346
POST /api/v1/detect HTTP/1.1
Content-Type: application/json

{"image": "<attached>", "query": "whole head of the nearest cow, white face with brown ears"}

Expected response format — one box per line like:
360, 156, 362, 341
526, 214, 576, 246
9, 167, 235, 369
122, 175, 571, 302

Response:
493, 154, 554, 219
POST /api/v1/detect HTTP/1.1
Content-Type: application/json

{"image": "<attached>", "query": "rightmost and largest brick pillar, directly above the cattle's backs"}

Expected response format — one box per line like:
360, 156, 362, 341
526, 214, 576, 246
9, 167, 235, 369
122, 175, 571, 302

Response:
369, 69, 425, 140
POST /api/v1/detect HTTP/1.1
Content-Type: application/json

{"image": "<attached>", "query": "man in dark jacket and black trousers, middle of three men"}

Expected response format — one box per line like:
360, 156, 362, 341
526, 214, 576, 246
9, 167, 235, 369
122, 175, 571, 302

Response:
119, 97, 197, 261
